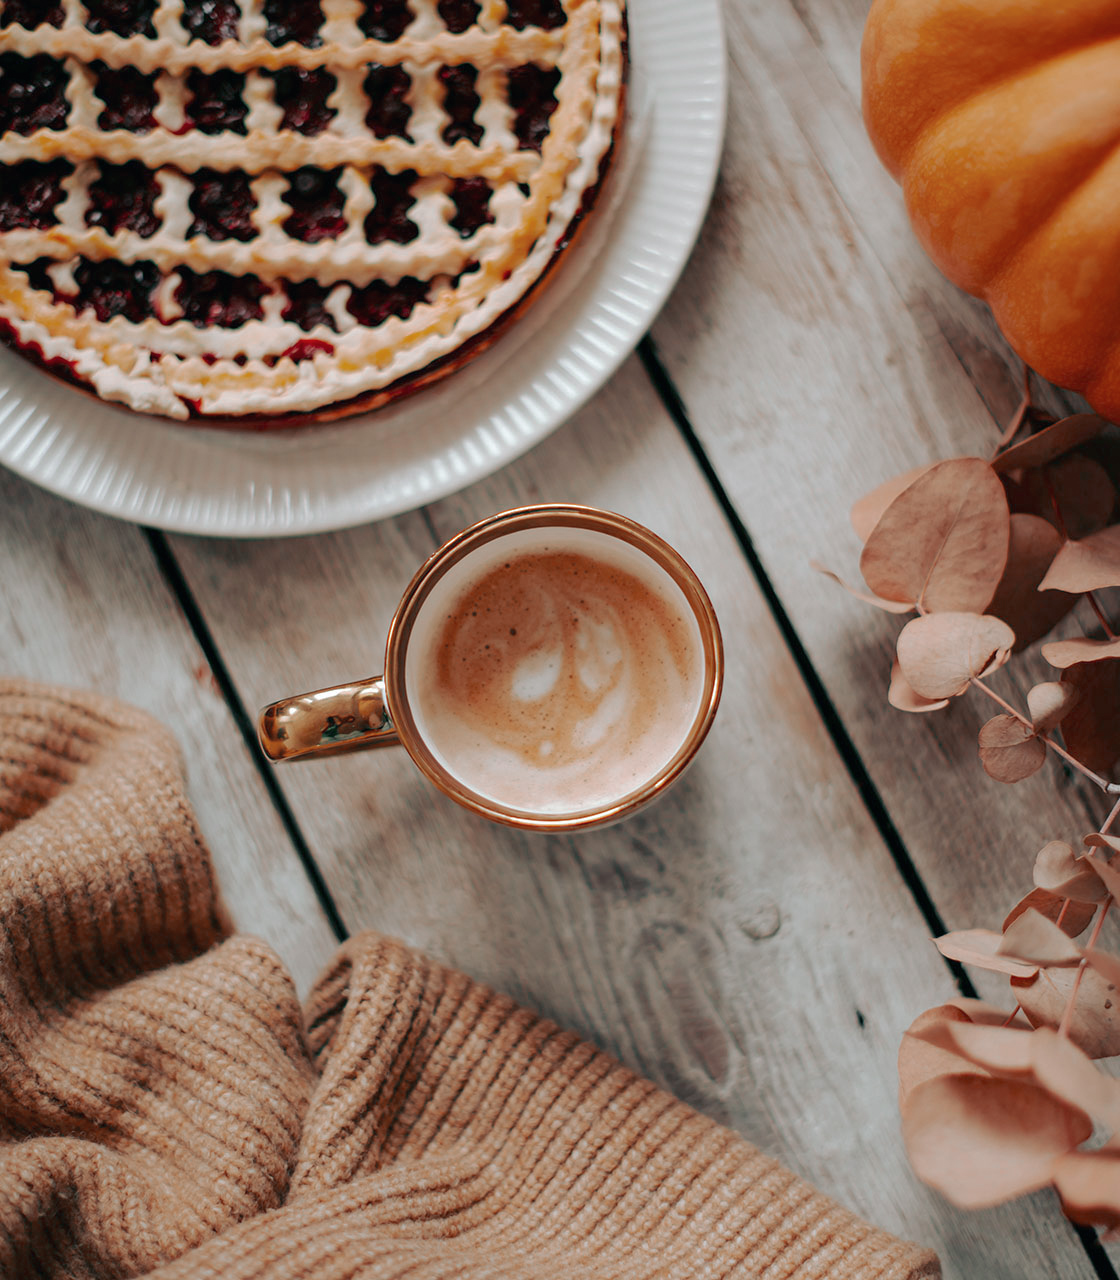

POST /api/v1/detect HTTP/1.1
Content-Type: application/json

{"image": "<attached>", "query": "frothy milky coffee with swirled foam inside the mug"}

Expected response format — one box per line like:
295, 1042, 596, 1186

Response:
407, 529, 704, 814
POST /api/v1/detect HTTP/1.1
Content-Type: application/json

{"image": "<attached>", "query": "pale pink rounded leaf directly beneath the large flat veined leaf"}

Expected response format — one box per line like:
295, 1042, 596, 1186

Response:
899, 612, 1015, 698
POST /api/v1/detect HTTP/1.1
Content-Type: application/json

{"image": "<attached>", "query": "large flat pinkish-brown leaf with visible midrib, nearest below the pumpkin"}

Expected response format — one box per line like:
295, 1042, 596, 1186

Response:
860, 458, 1010, 613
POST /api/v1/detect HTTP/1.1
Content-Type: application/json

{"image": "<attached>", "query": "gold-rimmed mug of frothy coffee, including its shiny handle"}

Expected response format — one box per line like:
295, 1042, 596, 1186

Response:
259, 504, 723, 832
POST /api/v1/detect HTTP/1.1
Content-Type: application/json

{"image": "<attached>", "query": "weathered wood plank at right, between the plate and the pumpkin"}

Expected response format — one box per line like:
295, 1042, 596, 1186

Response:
654, 0, 1105, 1276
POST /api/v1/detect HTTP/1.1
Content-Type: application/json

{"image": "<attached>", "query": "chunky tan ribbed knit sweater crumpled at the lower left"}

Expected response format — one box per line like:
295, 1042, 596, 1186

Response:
0, 681, 940, 1280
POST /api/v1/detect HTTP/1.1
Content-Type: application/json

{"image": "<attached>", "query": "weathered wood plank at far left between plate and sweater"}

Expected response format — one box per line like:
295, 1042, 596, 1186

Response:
0, 471, 334, 995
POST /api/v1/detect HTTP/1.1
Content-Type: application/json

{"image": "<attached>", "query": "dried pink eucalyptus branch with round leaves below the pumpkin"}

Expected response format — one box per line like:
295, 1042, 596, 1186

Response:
818, 371, 1120, 1231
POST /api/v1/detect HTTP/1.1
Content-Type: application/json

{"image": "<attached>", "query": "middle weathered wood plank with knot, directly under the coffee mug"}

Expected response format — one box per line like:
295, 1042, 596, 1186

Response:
173, 361, 1085, 1280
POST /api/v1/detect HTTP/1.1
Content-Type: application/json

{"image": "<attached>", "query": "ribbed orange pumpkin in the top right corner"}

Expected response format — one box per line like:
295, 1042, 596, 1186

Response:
863, 0, 1120, 419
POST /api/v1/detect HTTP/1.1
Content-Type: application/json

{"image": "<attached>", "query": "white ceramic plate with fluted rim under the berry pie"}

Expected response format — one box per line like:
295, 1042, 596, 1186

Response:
0, 0, 726, 538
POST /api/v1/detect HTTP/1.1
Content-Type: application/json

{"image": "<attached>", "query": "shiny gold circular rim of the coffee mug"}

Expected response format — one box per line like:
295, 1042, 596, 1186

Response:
384, 503, 723, 832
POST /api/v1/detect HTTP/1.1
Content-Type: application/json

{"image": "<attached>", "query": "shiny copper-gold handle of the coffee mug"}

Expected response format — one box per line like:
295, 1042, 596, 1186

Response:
257, 676, 401, 760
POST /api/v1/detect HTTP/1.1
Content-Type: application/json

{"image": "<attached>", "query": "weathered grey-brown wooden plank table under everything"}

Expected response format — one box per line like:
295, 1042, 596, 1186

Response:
0, 0, 1115, 1280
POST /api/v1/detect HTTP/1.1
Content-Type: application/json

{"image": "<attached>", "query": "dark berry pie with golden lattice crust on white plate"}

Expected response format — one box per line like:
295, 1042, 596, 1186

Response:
0, 0, 626, 425
